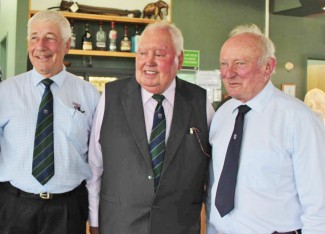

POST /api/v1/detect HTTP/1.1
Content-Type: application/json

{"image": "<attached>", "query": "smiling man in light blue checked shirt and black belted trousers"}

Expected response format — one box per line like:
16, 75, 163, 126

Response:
0, 11, 99, 234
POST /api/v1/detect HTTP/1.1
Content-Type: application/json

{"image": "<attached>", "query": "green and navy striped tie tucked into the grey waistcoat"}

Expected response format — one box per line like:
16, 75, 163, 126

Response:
149, 94, 166, 191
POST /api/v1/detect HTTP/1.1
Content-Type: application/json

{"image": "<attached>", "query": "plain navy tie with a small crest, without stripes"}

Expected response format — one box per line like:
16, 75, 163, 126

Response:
215, 105, 251, 217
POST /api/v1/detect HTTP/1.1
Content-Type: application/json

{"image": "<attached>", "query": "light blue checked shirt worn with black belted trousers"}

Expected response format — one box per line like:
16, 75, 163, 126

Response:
0, 68, 99, 193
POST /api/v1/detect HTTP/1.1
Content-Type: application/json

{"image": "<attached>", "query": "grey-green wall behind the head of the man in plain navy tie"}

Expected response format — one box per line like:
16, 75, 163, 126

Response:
173, 0, 325, 100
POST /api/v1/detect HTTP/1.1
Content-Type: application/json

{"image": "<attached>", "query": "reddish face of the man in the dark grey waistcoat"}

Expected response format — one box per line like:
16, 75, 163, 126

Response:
136, 29, 183, 94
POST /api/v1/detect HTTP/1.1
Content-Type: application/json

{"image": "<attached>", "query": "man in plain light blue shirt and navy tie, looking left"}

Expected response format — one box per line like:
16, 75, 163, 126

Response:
207, 25, 325, 234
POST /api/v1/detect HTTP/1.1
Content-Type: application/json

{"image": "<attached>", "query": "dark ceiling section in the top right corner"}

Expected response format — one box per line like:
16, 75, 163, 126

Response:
270, 0, 325, 17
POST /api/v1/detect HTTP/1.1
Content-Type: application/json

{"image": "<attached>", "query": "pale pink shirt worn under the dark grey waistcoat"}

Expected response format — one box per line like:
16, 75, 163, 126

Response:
87, 80, 214, 227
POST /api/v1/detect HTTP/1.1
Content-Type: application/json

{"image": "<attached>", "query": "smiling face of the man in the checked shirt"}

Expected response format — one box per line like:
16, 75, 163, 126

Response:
28, 21, 70, 78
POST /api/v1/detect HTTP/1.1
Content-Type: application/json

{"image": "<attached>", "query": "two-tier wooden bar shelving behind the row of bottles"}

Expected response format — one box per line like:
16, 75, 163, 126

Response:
29, 10, 155, 83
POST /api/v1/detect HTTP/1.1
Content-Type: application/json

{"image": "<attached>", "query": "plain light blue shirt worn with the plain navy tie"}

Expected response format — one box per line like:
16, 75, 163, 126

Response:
207, 81, 325, 234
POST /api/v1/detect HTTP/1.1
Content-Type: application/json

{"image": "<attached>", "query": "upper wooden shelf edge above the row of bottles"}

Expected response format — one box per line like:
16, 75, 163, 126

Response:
30, 10, 156, 24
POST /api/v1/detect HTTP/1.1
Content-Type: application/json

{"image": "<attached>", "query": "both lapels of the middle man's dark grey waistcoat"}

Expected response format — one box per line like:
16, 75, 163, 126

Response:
122, 78, 193, 176
